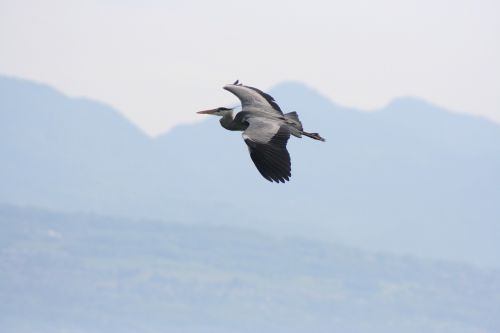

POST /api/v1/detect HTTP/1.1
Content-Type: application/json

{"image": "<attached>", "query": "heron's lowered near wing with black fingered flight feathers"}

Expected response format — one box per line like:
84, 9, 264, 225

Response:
242, 117, 291, 183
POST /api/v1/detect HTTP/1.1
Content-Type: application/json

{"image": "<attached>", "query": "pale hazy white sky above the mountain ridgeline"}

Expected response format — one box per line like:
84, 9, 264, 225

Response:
0, 0, 500, 134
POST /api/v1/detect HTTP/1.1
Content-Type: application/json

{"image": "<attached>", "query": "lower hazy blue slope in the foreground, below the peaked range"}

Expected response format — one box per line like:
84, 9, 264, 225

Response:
0, 205, 500, 333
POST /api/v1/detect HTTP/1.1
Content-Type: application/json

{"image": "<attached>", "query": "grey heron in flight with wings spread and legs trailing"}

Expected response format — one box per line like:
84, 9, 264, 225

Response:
197, 81, 325, 183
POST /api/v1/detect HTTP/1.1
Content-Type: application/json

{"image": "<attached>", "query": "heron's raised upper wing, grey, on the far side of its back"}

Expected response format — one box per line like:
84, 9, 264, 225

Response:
224, 82, 283, 116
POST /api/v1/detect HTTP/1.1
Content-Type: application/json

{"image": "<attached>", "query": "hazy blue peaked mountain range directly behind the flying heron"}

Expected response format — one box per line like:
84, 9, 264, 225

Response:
0, 77, 500, 267
